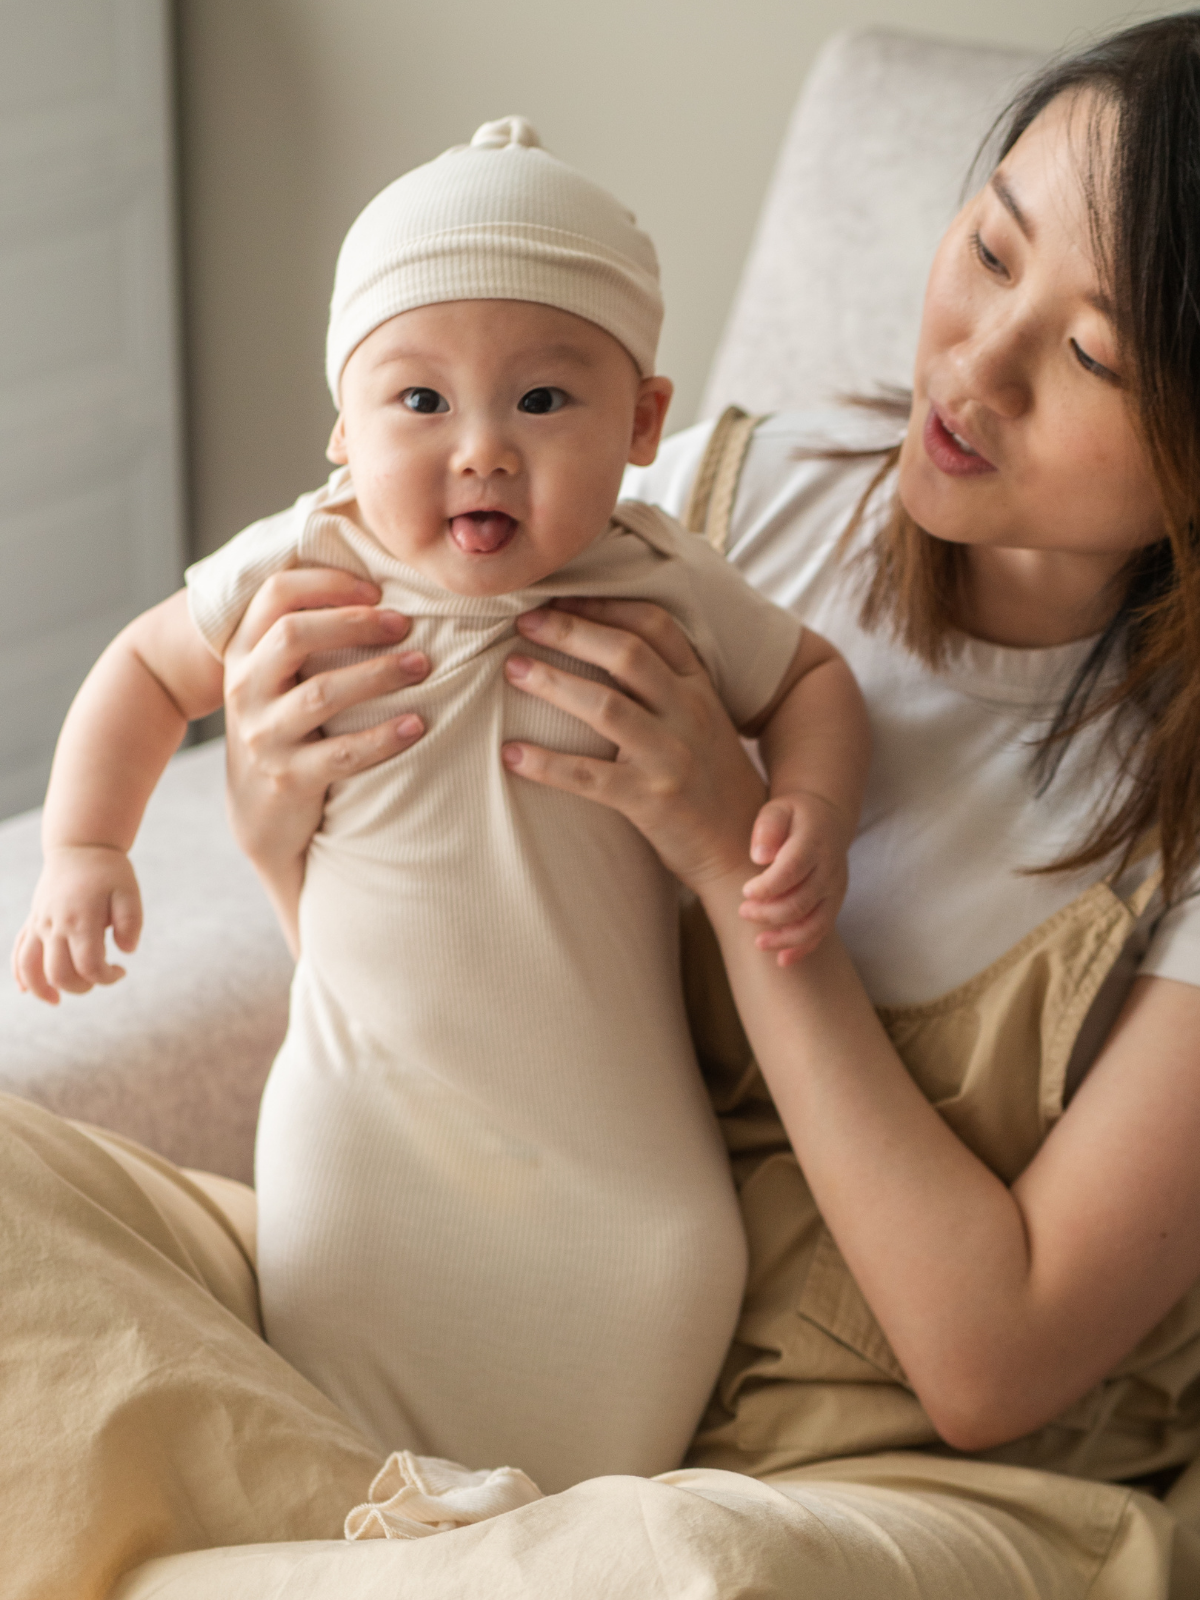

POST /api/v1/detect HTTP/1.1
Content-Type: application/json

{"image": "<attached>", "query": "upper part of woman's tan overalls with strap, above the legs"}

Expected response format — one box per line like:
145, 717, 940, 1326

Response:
672, 411, 1200, 1597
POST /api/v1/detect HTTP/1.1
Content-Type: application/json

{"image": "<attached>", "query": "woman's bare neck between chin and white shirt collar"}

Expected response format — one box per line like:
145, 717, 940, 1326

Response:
957, 546, 1128, 650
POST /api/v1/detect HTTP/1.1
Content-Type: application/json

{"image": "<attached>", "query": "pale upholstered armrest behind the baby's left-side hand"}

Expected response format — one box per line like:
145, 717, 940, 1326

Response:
0, 741, 291, 1181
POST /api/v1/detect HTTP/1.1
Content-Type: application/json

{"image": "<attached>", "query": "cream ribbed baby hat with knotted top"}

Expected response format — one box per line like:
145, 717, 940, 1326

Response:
325, 117, 662, 405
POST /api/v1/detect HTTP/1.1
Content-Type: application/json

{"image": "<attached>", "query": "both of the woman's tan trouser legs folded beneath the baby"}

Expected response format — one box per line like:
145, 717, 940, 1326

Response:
0, 1096, 1200, 1600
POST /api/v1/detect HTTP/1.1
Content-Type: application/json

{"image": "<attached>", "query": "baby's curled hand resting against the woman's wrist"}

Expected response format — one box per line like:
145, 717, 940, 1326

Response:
741, 792, 851, 966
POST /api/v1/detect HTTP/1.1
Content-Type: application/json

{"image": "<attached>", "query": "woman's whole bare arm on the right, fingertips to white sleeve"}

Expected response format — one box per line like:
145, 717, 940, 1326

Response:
507, 603, 1200, 1450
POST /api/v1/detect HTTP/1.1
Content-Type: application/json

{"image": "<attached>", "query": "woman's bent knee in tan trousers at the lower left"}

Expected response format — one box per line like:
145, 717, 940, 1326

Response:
0, 1096, 381, 1600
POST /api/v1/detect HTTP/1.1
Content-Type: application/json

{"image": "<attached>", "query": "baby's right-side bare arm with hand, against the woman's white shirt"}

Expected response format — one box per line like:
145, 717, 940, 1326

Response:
742, 630, 870, 966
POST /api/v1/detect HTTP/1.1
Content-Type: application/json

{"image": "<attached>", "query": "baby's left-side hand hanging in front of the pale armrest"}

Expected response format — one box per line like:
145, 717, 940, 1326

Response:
13, 845, 142, 1005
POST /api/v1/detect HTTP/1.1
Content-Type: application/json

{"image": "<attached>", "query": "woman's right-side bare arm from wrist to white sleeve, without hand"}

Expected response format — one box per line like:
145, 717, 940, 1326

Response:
702, 882, 1200, 1450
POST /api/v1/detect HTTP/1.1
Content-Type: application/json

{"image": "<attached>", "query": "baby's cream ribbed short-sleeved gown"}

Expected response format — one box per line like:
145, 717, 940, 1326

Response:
189, 472, 800, 1491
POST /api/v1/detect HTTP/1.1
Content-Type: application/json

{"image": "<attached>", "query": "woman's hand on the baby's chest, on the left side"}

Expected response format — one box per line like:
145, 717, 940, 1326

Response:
224, 568, 429, 954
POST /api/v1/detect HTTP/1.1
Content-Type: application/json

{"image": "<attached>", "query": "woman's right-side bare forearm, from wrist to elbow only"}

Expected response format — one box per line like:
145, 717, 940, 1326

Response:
702, 875, 1086, 1450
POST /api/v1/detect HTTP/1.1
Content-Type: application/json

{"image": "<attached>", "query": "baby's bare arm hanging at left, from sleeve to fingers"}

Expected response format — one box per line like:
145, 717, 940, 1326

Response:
13, 590, 222, 1003
